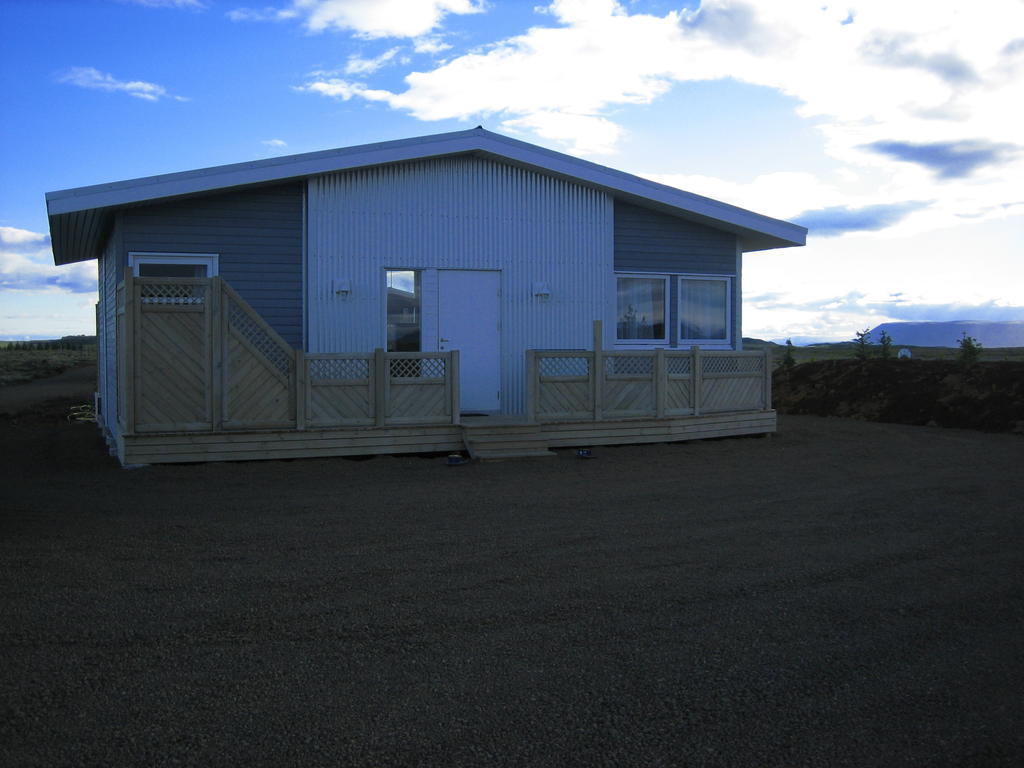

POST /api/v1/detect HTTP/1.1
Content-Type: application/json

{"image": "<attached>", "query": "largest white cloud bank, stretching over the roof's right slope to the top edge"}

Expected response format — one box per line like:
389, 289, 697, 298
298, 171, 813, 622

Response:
302, 0, 1024, 233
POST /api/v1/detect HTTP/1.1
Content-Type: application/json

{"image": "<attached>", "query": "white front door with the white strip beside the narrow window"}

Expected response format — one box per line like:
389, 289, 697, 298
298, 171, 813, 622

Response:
437, 269, 501, 412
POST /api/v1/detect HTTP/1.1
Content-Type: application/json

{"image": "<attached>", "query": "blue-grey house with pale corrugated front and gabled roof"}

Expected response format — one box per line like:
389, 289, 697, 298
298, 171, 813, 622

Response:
46, 128, 806, 461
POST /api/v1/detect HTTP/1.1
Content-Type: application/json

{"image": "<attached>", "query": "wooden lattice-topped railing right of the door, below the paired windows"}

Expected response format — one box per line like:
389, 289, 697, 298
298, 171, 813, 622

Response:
526, 328, 771, 422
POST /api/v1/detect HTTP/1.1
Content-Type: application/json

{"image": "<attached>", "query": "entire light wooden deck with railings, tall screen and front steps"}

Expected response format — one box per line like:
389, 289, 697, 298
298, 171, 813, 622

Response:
113, 273, 775, 464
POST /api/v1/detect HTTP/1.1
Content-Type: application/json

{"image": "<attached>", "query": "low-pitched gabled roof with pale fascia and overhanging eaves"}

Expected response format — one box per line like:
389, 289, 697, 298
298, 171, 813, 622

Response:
46, 127, 807, 264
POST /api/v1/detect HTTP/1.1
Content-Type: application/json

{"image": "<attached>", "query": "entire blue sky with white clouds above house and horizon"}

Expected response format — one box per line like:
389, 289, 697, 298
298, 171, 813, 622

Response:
0, 0, 1024, 342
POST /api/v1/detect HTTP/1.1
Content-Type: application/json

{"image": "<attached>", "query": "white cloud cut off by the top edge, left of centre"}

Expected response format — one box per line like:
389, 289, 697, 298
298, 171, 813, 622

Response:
227, 0, 484, 37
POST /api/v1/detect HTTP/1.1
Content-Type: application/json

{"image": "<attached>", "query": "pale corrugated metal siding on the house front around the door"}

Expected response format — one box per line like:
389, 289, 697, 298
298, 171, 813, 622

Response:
306, 157, 614, 413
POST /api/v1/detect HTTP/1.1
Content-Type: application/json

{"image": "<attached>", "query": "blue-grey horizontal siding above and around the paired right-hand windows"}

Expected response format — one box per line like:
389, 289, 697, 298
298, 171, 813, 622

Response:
614, 201, 741, 349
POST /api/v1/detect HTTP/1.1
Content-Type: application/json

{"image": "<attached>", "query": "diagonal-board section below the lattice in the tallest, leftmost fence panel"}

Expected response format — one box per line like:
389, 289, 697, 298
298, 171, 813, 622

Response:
135, 311, 210, 431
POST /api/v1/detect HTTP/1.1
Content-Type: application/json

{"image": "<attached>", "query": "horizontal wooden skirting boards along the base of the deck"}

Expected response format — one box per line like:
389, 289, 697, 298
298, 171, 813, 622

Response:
118, 411, 776, 464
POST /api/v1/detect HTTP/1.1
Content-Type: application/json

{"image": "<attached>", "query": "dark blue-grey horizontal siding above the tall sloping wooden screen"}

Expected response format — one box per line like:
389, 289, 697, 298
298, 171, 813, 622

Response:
121, 183, 303, 347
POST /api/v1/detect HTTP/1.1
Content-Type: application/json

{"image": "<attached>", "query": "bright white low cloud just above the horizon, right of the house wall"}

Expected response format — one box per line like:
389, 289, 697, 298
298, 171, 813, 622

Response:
742, 214, 1024, 342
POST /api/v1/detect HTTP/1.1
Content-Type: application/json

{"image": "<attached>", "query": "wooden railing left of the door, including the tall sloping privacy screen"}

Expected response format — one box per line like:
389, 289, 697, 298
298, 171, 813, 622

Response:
117, 271, 459, 434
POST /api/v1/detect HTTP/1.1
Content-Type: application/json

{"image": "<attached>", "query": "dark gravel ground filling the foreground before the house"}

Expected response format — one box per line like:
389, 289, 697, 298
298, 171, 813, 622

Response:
0, 385, 1024, 767
